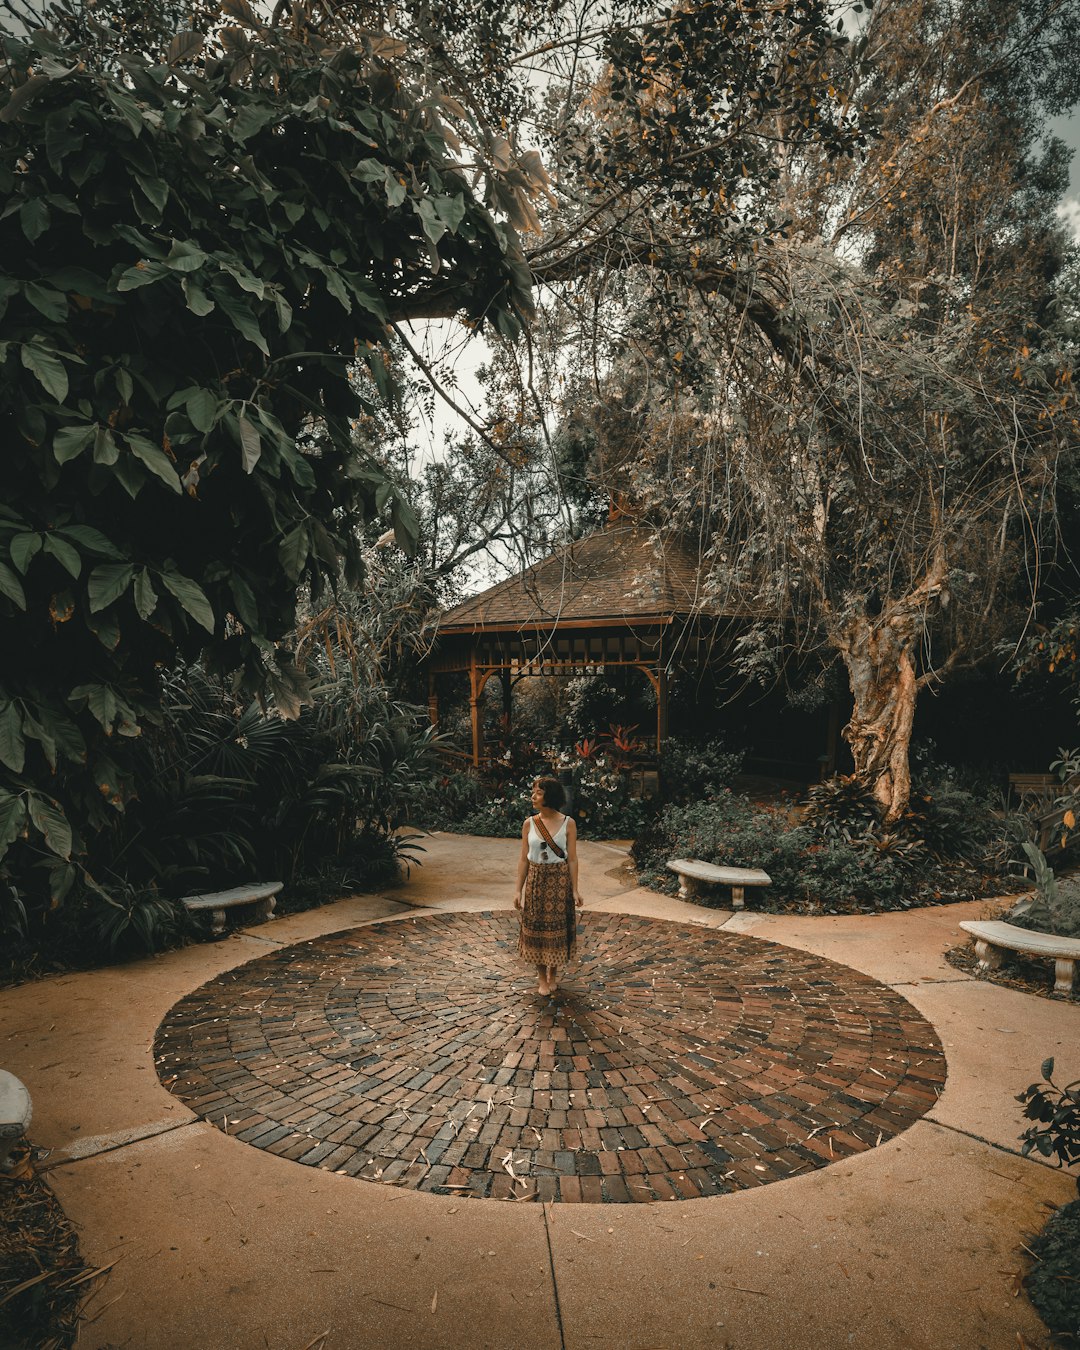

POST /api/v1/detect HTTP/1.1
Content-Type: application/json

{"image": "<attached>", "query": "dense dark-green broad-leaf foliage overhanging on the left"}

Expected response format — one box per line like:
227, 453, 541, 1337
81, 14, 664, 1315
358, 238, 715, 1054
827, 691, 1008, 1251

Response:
0, 22, 529, 899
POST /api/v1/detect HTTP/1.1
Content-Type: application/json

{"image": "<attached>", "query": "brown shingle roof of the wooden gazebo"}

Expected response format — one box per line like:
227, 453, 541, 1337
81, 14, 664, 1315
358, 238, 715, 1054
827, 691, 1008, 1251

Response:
439, 521, 716, 633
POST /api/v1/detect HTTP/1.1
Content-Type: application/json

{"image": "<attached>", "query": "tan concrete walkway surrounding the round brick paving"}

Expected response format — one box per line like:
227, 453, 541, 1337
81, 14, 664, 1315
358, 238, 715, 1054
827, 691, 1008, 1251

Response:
0, 836, 1080, 1350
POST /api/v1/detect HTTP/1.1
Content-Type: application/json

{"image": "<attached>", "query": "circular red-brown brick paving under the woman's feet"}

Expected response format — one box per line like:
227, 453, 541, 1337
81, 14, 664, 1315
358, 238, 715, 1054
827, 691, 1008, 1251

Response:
155, 911, 945, 1202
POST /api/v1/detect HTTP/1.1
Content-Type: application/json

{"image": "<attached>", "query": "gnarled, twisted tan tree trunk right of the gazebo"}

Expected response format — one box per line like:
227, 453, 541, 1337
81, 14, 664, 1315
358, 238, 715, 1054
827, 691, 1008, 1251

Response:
837, 614, 917, 821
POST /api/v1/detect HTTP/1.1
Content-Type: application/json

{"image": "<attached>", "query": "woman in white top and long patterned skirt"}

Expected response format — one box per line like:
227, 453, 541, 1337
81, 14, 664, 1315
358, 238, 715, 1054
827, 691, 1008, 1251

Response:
514, 778, 583, 994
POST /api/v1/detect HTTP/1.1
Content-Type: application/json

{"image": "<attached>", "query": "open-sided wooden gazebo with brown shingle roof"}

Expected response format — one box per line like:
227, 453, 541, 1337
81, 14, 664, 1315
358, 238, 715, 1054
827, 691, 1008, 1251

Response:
428, 520, 733, 765
